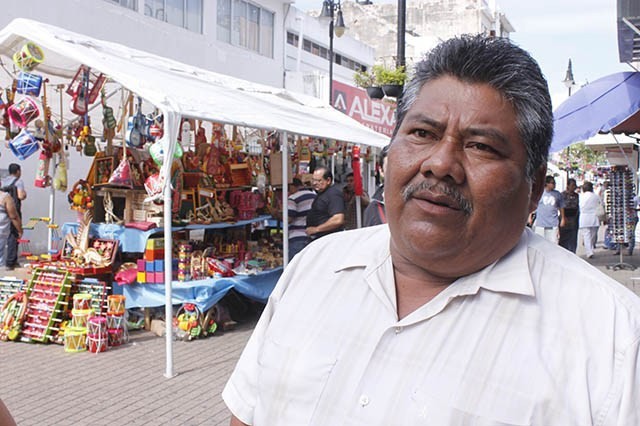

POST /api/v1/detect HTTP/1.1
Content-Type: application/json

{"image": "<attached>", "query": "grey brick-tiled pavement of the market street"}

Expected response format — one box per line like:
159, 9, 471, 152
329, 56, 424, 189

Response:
0, 235, 640, 426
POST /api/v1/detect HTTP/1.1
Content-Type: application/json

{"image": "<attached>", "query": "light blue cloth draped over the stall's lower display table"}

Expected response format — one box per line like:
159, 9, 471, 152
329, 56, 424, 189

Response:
121, 268, 282, 312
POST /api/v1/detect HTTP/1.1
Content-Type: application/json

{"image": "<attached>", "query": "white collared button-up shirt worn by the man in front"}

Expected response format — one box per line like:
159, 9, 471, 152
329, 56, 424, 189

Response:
222, 225, 640, 426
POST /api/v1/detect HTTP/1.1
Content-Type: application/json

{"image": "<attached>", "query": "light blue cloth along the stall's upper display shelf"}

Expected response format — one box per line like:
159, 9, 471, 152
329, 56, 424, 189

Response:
61, 215, 271, 253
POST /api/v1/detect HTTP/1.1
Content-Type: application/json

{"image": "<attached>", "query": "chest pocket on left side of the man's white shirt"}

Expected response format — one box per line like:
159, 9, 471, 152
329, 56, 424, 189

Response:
255, 338, 337, 426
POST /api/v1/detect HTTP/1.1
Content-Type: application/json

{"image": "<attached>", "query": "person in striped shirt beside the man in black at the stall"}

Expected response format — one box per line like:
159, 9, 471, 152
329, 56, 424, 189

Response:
287, 178, 316, 260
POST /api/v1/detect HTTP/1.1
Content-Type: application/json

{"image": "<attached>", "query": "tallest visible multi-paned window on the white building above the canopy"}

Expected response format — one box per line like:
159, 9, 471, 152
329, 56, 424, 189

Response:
216, 0, 274, 58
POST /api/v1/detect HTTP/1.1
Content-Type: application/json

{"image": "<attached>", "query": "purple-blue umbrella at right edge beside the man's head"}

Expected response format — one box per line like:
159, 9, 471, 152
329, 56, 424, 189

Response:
551, 72, 640, 152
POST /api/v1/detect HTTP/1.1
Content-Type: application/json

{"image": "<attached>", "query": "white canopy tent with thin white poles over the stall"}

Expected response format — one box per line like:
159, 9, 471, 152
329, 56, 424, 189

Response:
0, 19, 389, 377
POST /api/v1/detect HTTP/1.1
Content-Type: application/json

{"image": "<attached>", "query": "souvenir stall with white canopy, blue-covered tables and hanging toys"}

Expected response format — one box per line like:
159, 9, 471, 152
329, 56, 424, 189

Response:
0, 19, 388, 377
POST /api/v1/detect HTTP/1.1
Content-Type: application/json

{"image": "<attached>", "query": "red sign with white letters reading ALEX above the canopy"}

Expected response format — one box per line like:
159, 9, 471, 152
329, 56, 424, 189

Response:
333, 80, 396, 136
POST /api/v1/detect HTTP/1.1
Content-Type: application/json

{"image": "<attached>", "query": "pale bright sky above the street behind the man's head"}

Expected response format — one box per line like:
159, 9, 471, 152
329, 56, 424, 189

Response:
294, 0, 632, 108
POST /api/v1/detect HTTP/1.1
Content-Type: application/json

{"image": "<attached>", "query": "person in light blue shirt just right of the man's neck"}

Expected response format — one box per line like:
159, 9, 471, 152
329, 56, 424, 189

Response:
529, 176, 564, 244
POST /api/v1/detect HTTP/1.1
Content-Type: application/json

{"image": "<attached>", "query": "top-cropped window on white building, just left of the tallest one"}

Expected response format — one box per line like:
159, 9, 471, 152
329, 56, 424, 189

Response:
144, 0, 202, 33
